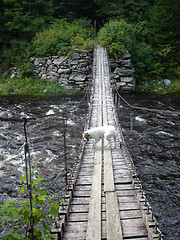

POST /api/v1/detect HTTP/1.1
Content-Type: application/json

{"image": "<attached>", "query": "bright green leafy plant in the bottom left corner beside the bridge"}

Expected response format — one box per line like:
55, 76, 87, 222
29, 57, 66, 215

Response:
0, 174, 63, 240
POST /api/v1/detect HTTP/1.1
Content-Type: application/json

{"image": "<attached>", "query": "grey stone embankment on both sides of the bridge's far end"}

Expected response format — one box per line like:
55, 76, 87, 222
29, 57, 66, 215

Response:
7, 50, 136, 91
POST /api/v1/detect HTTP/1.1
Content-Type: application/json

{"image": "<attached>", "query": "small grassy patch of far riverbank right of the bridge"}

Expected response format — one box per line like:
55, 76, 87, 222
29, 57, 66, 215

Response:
136, 79, 180, 95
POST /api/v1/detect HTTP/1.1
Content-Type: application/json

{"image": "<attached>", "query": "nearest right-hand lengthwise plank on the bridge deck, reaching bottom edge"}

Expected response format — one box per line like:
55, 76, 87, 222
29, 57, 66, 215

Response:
106, 192, 123, 240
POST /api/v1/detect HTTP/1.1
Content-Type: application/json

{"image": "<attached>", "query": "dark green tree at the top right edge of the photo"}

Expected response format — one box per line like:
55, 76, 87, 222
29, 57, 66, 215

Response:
149, 0, 180, 75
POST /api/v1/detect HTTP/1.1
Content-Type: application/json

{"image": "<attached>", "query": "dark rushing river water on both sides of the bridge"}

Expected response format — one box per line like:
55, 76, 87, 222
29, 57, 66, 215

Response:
0, 94, 180, 240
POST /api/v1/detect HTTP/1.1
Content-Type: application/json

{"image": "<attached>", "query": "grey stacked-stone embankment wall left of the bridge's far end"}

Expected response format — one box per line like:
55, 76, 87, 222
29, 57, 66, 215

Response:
30, 50, 93, 89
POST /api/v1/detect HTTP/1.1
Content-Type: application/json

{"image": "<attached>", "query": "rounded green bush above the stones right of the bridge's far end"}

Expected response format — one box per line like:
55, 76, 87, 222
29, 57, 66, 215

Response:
97, 20, 153, 80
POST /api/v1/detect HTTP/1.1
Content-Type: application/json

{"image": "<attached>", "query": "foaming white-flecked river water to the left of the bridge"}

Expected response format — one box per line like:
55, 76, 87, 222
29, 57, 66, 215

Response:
0, 96, 87, 203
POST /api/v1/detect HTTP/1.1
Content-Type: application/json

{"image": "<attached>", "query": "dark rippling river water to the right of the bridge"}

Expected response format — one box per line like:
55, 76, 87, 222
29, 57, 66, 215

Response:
118, 94, 180, 240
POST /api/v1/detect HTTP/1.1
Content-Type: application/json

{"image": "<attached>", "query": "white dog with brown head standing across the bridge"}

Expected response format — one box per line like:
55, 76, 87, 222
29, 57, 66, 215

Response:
83, 125, 117, 148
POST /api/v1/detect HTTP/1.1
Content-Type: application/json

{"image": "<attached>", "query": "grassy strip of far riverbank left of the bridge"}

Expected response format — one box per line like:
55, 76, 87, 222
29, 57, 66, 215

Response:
0, 76, 83, 97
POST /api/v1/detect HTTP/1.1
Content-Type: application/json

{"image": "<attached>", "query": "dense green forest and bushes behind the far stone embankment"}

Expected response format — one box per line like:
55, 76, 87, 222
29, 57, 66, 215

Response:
0, 0, 180, 89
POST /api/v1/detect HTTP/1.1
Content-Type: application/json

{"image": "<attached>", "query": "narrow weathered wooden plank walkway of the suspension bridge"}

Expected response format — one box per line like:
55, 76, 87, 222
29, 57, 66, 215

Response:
52, 46, 161, 240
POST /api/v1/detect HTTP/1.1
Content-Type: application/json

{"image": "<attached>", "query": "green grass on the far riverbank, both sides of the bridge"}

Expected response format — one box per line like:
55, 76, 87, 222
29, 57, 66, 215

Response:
0, 76, 180, 97
